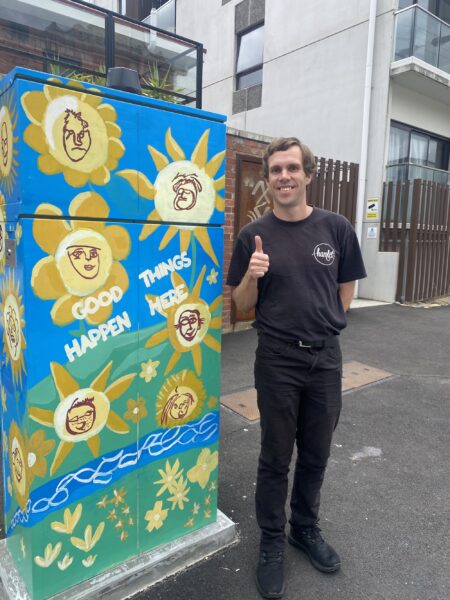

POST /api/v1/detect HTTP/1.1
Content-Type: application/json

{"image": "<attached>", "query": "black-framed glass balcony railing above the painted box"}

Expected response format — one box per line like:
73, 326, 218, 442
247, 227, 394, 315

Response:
0, 0, 203, 108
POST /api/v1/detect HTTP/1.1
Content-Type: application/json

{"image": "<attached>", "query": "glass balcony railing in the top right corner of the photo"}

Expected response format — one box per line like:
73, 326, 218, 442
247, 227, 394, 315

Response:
393, 5, 450, 73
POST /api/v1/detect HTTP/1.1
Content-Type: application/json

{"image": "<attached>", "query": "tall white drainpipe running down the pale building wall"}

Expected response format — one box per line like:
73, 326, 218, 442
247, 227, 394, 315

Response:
355, 0, 377, 298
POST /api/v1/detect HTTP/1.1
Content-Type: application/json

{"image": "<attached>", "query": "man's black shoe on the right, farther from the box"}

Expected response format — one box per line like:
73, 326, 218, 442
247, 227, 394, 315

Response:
288, 525, 341, 573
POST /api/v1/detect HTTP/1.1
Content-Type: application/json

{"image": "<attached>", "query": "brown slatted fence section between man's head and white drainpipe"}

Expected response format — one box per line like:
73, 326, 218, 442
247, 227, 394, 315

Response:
307, 158, 358, 226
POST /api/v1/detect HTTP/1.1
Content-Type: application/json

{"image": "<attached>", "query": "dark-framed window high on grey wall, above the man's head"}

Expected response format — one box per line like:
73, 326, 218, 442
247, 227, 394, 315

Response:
236, 25, 264, 90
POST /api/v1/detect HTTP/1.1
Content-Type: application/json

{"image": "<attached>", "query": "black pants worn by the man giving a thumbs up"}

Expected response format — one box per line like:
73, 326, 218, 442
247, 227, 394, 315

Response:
255, 335, 342, 550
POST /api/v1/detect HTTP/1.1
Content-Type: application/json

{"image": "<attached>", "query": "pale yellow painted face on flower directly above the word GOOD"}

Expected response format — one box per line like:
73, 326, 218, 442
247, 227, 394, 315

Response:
55, 229, 113, 296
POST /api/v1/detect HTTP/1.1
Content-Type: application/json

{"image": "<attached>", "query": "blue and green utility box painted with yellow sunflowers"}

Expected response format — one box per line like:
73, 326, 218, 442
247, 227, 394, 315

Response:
0, 68, 225, 600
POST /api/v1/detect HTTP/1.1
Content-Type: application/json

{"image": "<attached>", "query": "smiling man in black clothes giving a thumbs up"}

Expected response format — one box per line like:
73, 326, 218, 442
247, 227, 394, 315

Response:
227, 138, 366, 598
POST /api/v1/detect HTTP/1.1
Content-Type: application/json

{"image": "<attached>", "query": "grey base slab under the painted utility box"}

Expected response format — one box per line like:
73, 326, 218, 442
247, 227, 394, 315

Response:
0, 510, 237, 600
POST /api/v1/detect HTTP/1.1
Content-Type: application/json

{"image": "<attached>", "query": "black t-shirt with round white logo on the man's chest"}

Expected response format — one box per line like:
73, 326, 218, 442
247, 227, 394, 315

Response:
227, 208, 366, 341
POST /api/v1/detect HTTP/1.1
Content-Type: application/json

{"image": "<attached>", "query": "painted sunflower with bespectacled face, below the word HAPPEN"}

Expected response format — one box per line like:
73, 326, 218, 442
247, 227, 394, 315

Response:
29, 361, 136, 475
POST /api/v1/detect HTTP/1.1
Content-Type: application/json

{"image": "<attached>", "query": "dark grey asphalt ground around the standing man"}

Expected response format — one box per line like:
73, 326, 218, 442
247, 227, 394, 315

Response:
0, 305, 450, 600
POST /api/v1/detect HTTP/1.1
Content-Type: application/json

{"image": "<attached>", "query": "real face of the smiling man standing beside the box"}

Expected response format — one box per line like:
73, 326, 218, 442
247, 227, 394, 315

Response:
267, 146, 311, 212
